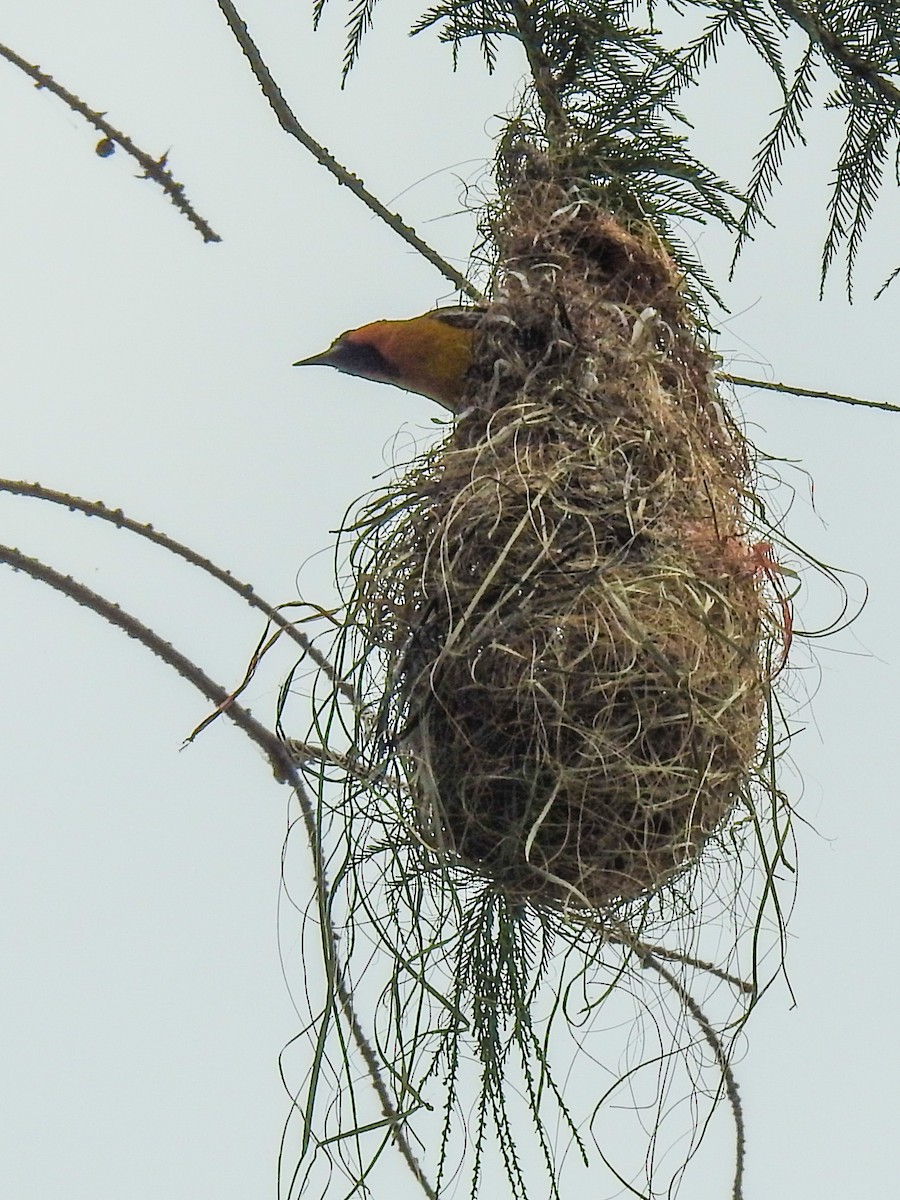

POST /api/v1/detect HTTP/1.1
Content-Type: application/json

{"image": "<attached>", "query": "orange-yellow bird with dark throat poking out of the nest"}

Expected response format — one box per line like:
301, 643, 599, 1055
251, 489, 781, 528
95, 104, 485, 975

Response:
294, 307, 481, 413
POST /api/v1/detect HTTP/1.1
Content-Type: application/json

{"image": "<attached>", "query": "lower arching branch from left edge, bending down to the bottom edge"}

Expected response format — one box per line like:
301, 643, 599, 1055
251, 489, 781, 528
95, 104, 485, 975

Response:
0, 545, 436, 1200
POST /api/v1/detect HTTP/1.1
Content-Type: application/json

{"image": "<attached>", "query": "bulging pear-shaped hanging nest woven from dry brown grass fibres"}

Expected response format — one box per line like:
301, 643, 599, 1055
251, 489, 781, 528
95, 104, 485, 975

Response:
359, 185, 768, 908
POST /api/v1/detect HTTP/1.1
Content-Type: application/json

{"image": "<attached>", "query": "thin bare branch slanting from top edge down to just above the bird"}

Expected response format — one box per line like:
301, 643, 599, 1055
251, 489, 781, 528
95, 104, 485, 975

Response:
216, 0, 484, 302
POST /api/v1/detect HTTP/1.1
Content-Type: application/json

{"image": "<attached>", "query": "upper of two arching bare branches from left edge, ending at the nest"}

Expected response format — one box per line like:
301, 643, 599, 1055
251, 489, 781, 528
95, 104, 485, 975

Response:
0, 479, 356, 705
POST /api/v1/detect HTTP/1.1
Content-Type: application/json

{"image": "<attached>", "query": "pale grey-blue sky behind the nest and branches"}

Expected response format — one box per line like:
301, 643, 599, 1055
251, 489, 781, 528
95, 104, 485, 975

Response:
0, 0, 900, 1200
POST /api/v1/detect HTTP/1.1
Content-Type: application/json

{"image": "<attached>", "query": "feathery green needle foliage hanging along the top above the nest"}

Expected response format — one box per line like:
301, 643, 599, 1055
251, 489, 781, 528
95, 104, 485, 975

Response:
314, 0, 900, 295
